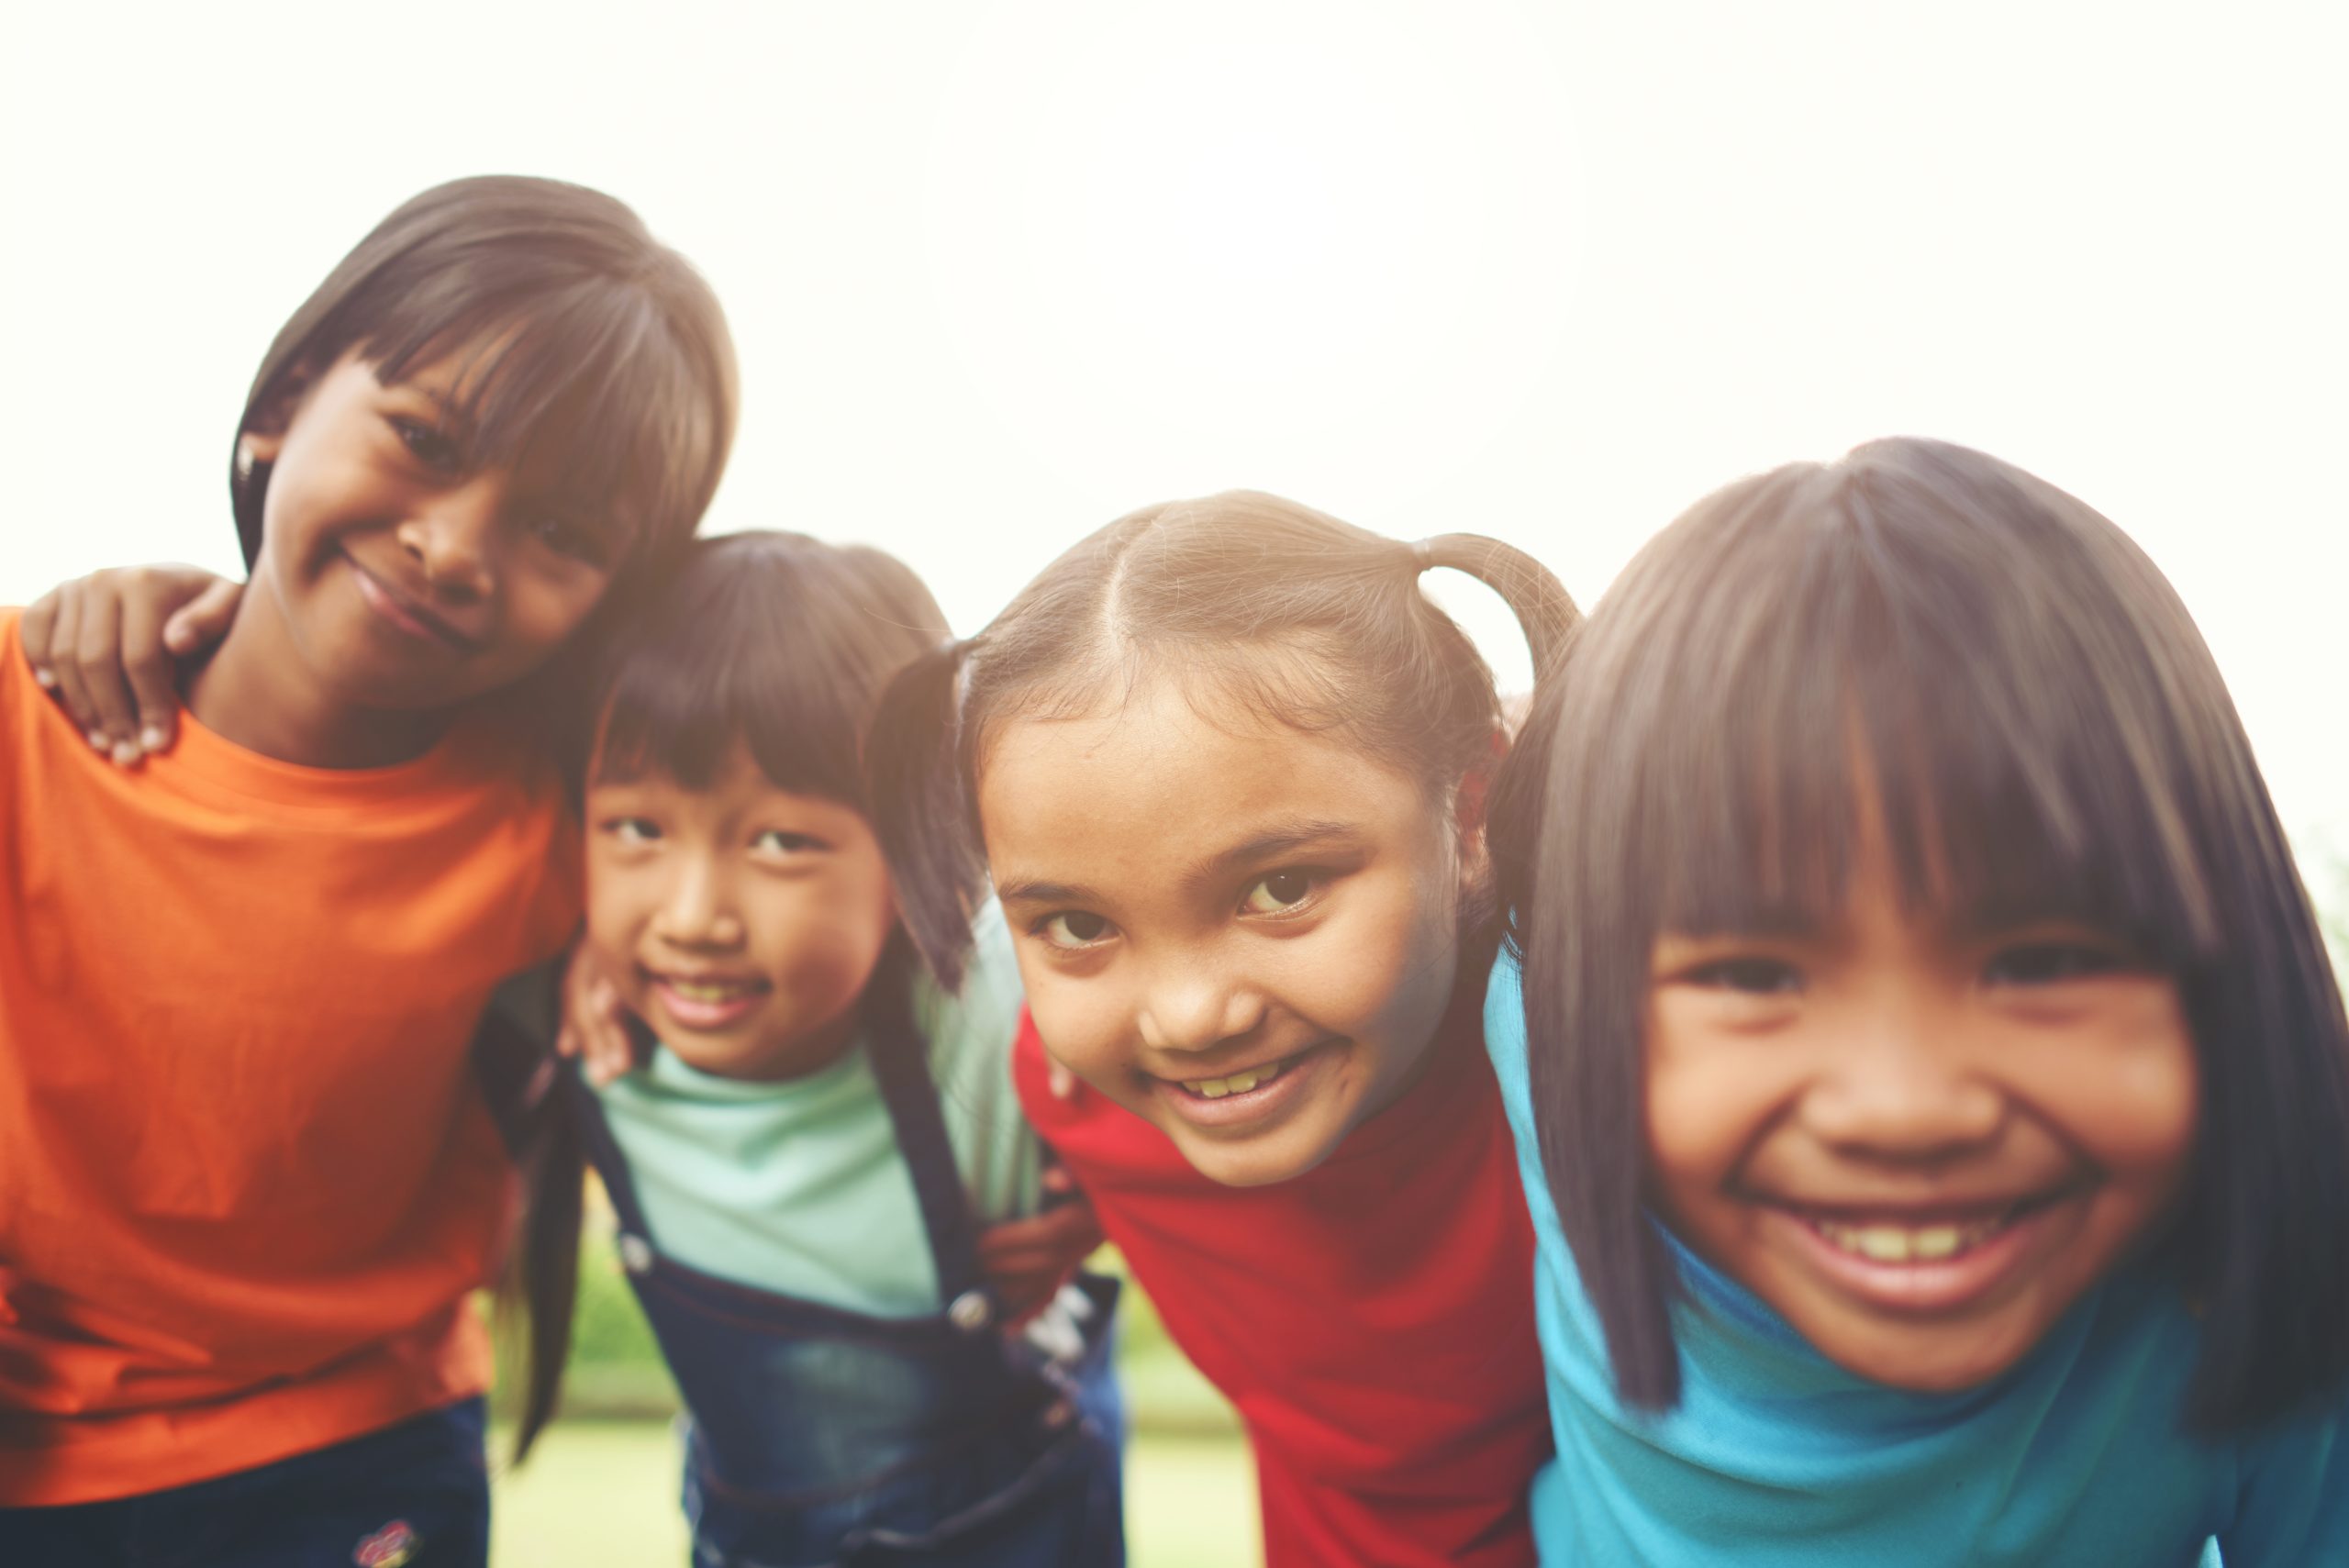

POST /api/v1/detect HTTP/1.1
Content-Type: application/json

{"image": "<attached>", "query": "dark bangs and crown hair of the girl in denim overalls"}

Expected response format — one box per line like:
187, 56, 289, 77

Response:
584, 533, 947, 815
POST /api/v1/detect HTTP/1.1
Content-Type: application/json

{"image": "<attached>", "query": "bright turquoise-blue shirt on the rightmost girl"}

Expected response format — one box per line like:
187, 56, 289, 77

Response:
1485, 953, 2349, 1568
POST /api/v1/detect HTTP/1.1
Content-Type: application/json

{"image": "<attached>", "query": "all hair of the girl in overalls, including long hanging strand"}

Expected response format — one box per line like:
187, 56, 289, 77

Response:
507, 533, 947, 1462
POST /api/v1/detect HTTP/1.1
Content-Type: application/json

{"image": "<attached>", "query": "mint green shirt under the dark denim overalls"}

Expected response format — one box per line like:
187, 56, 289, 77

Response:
601, 904, 1039, 1317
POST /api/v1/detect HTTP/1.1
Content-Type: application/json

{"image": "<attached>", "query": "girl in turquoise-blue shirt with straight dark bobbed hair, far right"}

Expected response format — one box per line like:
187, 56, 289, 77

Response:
1486, 439, 2349, 1568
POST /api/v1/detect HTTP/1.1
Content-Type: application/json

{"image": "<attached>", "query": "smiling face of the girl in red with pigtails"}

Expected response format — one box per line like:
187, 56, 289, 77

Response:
977, 681, 1475, 1185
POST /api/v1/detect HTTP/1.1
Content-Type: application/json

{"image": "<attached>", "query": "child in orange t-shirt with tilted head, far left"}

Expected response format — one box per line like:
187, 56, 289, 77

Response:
0, 178, 735, 1568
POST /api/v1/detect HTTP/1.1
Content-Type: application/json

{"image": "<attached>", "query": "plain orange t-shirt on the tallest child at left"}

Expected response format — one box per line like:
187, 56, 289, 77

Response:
0, 610, 578, 1507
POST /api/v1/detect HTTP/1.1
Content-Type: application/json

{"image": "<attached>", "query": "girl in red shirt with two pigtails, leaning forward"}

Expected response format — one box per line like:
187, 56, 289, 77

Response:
874, 493, 1574, 1568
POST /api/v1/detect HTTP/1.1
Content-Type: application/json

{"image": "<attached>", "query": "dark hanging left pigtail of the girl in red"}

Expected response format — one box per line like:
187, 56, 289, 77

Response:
864, 639, 985, 991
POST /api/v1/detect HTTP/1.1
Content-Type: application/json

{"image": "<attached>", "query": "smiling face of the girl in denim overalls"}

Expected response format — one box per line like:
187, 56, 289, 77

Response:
587, 744, 897, 1080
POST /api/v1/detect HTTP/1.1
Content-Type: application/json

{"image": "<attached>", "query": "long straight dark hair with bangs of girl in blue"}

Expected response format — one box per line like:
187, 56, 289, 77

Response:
1492, 439, 2349, 1429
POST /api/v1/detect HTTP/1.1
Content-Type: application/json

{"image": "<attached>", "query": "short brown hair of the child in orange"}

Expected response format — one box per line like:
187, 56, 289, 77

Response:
230, 176, 738, 587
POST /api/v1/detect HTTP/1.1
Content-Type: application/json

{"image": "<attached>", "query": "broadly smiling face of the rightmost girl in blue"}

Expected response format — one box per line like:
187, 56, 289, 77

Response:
1647, 850, 2199, 1392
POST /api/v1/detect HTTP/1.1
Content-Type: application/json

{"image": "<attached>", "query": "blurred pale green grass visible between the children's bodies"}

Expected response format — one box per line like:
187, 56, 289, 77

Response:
491, 1225, 1264, 1568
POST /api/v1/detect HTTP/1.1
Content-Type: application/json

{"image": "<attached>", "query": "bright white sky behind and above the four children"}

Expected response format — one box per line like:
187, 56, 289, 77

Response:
0, 0, 2349, 883
